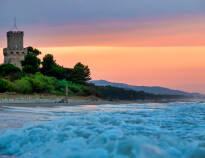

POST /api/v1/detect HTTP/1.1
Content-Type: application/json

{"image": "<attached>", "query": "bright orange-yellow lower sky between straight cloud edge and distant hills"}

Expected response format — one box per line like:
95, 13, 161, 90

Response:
22, 47, 205, 93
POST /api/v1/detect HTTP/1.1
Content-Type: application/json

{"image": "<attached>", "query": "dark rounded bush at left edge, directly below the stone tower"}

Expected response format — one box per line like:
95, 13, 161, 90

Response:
0, 64, 22, 81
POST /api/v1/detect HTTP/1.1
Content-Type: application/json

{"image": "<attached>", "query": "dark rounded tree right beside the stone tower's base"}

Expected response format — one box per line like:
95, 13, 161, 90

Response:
21, 53, 41, 74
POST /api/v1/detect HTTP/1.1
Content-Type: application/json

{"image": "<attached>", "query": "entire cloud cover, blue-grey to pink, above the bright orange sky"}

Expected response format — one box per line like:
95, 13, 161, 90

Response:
0, 0, 205, 46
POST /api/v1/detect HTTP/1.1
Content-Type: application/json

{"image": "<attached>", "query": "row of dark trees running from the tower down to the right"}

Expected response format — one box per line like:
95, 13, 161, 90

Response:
22, 47, 91, 84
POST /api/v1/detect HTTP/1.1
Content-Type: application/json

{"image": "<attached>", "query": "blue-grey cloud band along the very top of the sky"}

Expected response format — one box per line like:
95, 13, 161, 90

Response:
0, 0, 205, 25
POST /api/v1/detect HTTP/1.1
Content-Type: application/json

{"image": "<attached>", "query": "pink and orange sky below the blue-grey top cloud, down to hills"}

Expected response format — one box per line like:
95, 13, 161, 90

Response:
0, 16, 205, 94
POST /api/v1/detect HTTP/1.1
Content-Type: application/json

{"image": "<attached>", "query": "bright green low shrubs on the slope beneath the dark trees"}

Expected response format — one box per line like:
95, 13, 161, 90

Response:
0, 72, 101, 97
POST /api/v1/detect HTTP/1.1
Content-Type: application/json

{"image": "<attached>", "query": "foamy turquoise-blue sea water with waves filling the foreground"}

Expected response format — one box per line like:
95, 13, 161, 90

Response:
0, 102, 205, 158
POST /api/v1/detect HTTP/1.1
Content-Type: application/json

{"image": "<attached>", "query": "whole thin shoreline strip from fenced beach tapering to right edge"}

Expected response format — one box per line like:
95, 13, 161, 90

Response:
0, 94, 200, 107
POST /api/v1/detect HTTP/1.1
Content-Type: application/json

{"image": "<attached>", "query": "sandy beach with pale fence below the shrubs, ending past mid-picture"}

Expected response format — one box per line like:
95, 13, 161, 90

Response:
0, 94, 135, 107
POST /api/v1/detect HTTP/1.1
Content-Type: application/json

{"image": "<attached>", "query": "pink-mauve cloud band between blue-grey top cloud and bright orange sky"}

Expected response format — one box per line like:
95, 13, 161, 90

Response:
6, 16, 202, 47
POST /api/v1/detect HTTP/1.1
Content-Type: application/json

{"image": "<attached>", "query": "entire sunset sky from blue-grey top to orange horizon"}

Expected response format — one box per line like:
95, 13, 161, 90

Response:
0, 0, 205, 93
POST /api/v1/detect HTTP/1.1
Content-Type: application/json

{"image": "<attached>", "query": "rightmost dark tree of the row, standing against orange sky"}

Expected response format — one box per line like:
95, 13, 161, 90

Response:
70, 62, 91, 84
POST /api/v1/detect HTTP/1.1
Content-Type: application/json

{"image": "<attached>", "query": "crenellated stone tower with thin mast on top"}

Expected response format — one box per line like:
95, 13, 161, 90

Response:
3, 19, 27, 68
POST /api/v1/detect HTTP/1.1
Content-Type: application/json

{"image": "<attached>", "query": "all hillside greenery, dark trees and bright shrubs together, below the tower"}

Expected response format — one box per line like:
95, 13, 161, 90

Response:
0, 47, 98, 97
